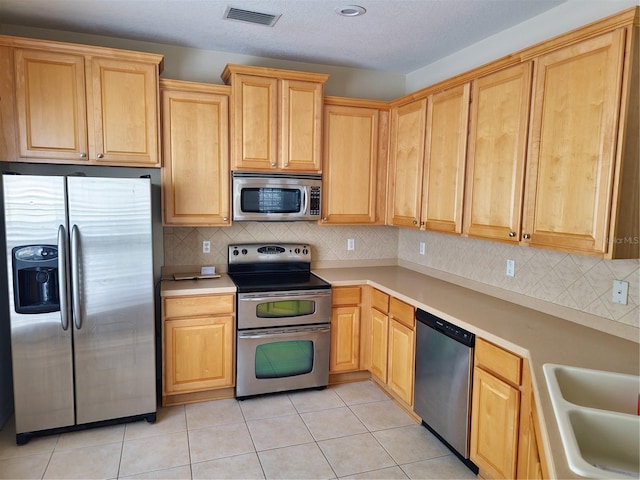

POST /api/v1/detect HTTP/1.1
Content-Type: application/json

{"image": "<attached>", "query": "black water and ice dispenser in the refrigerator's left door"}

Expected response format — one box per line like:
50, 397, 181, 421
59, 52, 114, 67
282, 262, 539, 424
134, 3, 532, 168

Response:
12, 245, 60, 314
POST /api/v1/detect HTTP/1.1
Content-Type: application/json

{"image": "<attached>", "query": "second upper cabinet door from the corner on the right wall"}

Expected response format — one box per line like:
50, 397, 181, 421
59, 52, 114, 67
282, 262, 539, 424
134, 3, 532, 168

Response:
421, 84, 470, 233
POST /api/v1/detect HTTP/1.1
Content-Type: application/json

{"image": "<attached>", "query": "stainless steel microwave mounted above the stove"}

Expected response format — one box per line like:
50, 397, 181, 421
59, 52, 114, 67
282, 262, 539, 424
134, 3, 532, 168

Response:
232, 172, 322, 222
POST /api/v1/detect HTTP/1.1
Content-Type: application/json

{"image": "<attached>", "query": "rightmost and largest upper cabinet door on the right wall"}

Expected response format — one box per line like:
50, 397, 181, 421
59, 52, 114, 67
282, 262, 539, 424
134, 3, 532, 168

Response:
524, 29, 637, 253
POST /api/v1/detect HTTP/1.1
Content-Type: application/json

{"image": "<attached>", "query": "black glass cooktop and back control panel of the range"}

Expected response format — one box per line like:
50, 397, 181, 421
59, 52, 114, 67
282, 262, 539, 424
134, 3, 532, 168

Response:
227, 243, 331, 293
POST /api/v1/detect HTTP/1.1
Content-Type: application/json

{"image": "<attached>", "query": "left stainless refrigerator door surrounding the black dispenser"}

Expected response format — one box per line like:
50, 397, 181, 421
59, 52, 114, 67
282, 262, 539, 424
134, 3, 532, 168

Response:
2, 175, 74, 433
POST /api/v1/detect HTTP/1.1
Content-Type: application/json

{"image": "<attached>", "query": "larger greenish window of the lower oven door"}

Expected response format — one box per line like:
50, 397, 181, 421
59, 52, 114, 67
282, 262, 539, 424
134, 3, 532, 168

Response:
255, 340, 313, 378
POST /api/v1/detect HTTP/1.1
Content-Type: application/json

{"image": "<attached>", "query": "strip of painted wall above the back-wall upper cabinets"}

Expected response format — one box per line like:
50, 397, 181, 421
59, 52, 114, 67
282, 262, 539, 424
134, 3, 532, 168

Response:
0, 25, 405, 100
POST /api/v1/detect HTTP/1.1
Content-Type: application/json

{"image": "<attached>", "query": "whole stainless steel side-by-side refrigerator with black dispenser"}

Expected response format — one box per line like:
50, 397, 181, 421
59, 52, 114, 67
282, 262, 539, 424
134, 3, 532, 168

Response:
2, 174, 156, 444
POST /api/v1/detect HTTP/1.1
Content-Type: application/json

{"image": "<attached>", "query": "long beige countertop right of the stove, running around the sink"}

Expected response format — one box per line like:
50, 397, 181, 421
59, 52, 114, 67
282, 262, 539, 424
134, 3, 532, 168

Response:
313, 266, 640, 478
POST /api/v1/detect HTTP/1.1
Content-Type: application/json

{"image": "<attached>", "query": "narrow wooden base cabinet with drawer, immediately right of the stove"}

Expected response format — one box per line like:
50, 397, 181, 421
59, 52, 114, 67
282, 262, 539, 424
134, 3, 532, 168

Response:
329, 287, 362, 373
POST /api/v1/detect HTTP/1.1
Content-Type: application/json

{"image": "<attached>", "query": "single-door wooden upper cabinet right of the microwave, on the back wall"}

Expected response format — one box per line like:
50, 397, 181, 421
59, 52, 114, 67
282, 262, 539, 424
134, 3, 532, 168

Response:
320, 97, 389, 225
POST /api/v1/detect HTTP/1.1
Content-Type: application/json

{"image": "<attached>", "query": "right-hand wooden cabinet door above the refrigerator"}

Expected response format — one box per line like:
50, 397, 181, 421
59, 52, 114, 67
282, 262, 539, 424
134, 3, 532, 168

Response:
87, 58, 160, 167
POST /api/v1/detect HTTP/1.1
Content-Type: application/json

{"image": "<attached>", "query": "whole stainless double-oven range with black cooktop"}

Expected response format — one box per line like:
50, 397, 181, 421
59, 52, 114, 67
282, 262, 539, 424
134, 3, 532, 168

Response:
228, 244, 331, 398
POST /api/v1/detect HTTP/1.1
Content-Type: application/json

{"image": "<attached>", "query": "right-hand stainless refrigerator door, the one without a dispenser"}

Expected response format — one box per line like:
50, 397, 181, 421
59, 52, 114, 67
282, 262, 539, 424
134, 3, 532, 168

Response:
67, 177, 156, 424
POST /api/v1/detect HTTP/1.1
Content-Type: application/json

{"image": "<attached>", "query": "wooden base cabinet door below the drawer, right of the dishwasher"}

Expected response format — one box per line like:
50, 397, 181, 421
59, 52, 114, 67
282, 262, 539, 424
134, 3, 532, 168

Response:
470, 368, 520, 478
